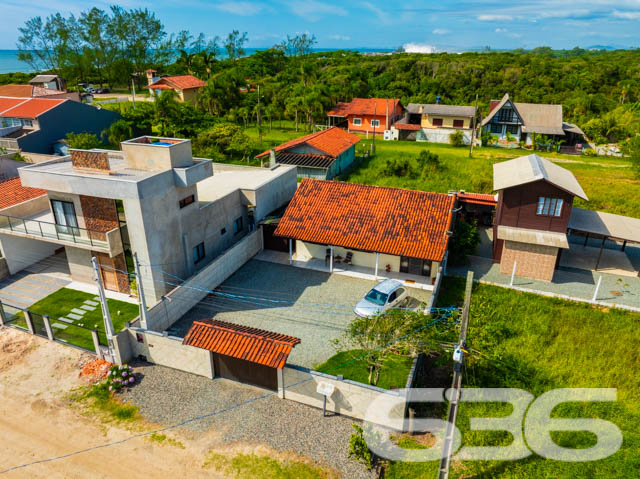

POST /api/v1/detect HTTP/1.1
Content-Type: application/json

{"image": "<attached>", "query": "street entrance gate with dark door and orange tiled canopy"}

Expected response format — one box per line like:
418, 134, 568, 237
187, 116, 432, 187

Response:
183, 319, 300, 391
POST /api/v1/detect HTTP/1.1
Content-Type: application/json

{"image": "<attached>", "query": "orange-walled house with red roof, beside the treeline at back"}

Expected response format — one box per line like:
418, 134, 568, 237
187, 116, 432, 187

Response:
327, 98, 404, 136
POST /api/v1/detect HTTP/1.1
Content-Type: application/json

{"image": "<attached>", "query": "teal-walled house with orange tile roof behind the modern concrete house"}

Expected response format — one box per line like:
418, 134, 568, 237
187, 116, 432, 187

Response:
256, 127, 360, 180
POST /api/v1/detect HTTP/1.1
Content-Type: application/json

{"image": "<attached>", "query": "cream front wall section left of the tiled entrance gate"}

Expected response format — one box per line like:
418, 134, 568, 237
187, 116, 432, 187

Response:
114, 328, 215, 379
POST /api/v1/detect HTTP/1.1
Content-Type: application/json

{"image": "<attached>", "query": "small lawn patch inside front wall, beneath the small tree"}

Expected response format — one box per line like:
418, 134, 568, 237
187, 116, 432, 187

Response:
316, 349, 413, 389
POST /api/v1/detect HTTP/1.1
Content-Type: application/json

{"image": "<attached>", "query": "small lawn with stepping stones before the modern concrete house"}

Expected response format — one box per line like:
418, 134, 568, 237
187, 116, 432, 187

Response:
17, 288, 139, 350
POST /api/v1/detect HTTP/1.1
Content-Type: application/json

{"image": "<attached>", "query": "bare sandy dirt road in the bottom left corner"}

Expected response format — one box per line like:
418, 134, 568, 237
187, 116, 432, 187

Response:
0, 327, 232, 479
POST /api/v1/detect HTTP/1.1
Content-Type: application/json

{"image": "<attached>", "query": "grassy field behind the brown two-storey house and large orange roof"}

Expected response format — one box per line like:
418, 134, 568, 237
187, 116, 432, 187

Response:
246, 121, 640, 218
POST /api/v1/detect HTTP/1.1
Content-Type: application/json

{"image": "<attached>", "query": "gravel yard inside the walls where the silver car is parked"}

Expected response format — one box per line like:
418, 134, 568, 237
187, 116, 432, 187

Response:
172, 259, 431, 368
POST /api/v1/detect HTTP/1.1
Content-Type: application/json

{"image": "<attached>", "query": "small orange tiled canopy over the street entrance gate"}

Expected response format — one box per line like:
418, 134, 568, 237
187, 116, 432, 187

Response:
182, 319, 300, 369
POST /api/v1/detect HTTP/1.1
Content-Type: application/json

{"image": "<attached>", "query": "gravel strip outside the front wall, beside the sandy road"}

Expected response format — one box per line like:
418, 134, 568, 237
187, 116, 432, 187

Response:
124, 363, 373, 479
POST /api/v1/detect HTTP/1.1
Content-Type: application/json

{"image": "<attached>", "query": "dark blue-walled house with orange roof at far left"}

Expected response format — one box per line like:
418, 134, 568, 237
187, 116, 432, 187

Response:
0, 97, 120, 155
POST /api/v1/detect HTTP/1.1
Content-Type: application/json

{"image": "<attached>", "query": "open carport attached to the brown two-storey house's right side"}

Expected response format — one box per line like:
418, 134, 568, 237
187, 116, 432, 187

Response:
560, 207, 640, 276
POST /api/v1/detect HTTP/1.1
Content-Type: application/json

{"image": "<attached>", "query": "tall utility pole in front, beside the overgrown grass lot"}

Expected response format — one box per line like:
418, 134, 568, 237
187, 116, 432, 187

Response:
438, 271, 473, 479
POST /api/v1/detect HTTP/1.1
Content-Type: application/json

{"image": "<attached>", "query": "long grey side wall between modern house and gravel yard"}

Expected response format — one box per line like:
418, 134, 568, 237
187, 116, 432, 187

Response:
143, 229, 262, 331
